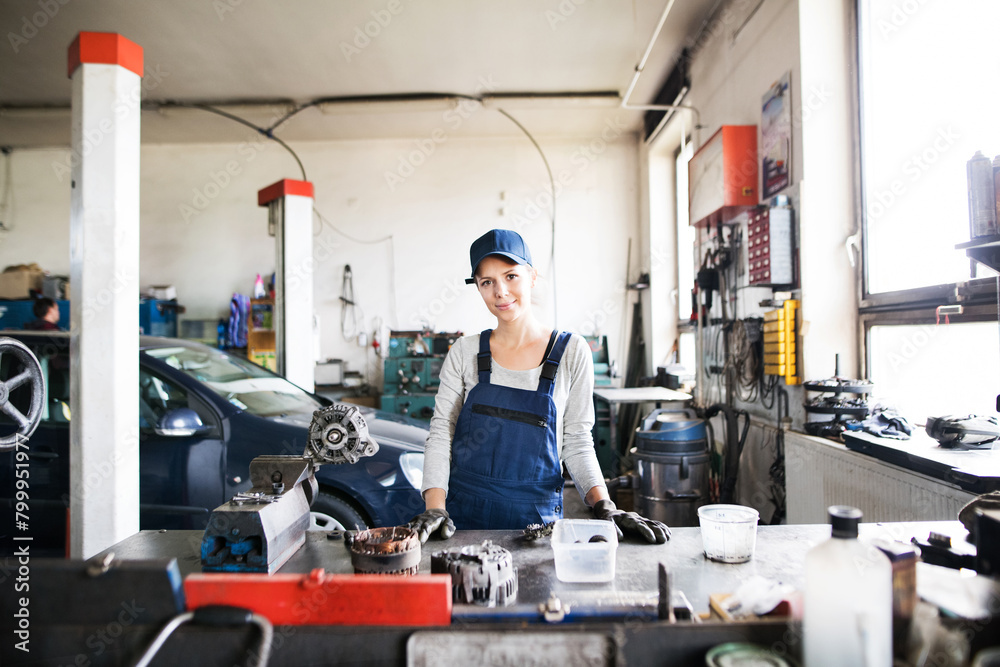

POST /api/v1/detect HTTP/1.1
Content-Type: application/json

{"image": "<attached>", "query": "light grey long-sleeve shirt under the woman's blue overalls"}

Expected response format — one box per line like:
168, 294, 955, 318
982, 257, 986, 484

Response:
420, 334, 604, 498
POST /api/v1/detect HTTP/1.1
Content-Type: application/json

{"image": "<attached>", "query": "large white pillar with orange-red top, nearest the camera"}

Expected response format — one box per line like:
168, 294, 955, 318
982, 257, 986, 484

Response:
69, 32, 143, 558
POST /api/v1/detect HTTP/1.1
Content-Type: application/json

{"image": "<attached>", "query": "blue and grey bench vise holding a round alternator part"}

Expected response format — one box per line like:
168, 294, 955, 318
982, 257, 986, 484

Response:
201, 404, 378, 574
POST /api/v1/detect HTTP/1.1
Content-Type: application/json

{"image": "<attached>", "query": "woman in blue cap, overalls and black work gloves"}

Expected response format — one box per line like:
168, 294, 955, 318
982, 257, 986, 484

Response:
409, 229, 670, 544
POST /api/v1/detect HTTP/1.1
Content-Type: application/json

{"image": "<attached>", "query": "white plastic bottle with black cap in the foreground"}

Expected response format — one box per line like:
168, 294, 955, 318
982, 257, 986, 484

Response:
803, 505, 892, 667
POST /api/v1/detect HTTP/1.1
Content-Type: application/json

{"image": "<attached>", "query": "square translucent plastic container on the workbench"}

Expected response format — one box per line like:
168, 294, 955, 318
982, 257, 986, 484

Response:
552, 519, 618, 583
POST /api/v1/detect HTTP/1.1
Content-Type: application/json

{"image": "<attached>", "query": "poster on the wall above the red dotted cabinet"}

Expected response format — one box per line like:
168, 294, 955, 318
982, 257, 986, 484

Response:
760, 72, 792, 199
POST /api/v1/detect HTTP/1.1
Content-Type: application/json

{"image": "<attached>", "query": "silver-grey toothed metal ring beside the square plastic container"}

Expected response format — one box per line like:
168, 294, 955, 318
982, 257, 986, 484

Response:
431, 540, 517, 607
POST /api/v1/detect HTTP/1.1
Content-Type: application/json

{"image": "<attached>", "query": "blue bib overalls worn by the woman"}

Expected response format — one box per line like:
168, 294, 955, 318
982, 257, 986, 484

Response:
446, 329, 570, 530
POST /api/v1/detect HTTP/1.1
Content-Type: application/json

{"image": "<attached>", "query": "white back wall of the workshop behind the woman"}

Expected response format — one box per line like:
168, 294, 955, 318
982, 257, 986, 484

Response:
0, 128, 639, 379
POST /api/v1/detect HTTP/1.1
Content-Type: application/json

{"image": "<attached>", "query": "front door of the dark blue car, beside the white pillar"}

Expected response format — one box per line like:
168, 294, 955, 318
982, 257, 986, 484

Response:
139, 361, 226, 529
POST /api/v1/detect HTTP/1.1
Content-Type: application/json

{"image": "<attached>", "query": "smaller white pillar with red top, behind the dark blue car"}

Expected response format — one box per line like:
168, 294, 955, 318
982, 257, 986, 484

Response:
257, 178, 316, 391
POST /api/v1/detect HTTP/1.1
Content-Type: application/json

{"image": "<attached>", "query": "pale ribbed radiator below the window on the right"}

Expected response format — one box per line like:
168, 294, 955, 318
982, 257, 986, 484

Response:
785, 432, 975, 523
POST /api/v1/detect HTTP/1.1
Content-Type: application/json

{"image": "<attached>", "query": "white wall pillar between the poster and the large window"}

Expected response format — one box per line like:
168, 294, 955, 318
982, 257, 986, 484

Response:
793, 0, 863, 378
